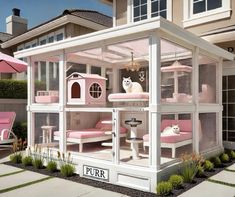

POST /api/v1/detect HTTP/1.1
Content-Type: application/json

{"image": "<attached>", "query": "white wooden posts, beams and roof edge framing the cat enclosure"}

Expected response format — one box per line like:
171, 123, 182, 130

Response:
15, 17, 234, 192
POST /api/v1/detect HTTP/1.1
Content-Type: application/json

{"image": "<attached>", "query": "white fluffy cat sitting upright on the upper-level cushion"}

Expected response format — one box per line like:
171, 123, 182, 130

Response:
122, 77, 143, 93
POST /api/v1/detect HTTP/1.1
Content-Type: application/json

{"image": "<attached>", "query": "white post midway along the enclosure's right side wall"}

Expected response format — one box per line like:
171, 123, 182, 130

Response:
191, 47, 201, 153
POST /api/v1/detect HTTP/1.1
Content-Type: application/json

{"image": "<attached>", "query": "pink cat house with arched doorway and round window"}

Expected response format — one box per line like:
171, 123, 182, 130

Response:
67, 72, 106, 105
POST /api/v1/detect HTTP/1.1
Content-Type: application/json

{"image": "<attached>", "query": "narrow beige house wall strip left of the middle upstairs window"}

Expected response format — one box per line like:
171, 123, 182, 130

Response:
116, 0, 127, 26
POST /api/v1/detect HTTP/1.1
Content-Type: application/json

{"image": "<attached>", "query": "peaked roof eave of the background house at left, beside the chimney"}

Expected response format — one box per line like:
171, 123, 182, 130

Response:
1, 14, 110, 48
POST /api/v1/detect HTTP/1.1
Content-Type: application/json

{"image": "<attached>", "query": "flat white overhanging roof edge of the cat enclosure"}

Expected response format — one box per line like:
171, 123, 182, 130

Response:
14, 17, 235, 60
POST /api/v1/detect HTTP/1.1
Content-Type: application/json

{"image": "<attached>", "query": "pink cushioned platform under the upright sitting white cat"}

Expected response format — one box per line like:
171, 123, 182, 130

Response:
108, 92, 149, 100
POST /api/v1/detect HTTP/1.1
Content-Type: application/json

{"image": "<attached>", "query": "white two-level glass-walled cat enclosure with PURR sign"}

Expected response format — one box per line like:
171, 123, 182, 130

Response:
15, 17, 234, 192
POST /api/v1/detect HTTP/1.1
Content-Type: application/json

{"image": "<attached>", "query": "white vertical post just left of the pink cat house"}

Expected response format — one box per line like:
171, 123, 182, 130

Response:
59, 51, 67, 153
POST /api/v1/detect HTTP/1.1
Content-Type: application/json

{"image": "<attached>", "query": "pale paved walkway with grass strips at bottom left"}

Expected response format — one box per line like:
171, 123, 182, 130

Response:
0, 155, 129, 197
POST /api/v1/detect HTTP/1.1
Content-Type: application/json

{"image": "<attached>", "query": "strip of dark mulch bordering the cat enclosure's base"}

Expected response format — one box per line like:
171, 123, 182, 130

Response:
5, 161, 235, 197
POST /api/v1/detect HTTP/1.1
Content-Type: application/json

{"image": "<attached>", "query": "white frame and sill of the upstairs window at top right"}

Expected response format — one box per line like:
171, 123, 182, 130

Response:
183, 0, 231, 27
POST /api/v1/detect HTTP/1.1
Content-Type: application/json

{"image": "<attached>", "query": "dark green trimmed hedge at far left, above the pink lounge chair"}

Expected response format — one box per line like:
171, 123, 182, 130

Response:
0, 79, 45, 99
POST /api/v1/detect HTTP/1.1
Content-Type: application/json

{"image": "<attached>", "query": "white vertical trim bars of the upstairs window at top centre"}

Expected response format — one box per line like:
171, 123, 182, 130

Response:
127, 0, 172, 23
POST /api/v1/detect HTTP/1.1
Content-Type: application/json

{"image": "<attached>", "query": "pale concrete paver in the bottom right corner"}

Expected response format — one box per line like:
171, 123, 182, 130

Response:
180, 181, 235, 197
